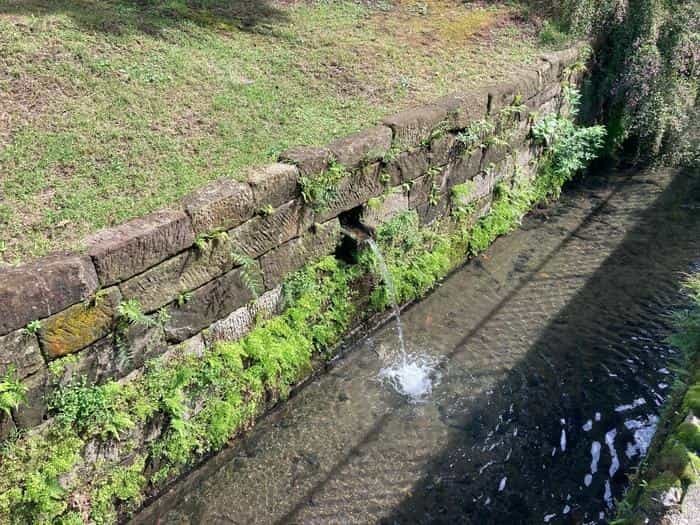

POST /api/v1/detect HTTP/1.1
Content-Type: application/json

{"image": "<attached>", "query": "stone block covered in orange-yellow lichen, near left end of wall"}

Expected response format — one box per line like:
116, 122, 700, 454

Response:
39, 286, 121, 359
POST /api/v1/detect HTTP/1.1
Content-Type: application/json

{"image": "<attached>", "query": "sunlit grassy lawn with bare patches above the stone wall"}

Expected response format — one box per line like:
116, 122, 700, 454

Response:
0, 0, 548, 264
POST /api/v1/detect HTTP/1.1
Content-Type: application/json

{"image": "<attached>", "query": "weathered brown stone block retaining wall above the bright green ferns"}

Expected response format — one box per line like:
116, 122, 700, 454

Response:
0, 47, 580, 446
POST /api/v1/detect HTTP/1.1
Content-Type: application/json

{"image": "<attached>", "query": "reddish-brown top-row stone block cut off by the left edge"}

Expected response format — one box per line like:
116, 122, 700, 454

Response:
0, 255, 98, 335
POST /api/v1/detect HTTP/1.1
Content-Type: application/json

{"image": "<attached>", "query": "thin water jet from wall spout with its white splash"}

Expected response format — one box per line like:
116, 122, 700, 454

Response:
367, 238, 438, 403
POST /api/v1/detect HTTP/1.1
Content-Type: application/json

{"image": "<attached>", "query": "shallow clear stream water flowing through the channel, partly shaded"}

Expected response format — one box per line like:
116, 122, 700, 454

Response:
135, 165, 700, 525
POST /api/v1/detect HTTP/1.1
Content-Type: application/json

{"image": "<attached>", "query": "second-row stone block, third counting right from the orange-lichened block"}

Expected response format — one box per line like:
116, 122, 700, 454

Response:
229, 200, 313, 258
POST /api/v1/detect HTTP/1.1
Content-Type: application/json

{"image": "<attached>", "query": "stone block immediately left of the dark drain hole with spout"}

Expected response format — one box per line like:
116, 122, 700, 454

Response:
260, 219, 341, 289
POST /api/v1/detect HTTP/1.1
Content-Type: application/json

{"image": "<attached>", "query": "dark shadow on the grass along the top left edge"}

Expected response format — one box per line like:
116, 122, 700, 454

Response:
0, 0, 288, 37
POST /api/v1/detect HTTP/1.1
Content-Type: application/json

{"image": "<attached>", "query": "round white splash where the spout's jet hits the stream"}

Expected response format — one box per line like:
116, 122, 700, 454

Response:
379, 354, 439, 403
